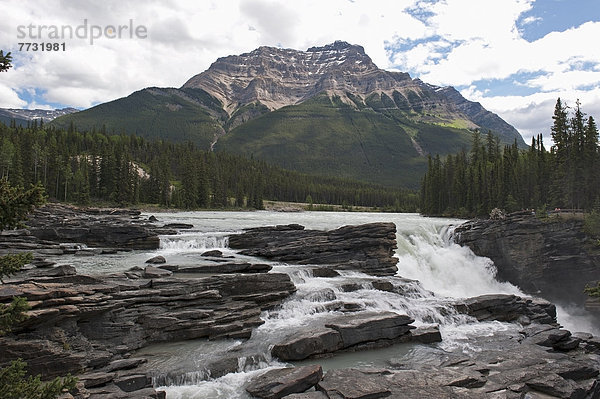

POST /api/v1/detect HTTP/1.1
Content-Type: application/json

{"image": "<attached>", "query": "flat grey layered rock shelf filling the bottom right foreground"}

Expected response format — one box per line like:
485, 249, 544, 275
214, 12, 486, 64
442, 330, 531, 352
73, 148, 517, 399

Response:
249, 324, 600, 399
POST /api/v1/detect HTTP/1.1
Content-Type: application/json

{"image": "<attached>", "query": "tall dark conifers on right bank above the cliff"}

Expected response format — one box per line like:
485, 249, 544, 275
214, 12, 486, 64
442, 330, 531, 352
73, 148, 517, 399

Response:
421, 98, 600, 217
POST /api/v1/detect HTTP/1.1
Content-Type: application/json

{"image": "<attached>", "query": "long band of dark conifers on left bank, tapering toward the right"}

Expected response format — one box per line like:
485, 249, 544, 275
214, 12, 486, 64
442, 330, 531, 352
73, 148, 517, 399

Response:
0, 122, 418, 212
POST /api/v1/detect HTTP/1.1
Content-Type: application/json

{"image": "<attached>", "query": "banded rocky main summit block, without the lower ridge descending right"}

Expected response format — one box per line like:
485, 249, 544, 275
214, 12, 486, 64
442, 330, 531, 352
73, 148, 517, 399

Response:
183, 41, 381, 114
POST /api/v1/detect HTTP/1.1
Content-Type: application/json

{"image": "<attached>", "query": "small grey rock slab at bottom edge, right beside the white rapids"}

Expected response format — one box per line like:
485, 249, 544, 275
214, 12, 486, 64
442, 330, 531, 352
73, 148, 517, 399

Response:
246, 365, 323, 399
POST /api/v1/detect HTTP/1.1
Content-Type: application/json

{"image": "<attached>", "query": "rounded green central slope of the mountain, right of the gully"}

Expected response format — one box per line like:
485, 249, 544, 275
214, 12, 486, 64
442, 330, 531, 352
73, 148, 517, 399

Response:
215, 95, 469, 188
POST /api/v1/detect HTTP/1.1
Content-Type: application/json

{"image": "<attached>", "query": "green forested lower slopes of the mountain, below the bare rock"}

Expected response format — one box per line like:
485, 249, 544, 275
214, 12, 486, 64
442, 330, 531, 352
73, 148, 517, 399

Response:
50, 85, 512, 190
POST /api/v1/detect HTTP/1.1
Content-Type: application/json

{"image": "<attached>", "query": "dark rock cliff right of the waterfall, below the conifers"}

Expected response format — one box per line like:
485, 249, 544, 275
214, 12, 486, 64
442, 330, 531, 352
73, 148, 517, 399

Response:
455, 215, 600, 305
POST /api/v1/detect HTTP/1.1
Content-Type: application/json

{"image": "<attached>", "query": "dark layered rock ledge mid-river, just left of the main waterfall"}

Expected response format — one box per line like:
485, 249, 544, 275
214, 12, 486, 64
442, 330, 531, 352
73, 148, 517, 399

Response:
229, 223, 398, 276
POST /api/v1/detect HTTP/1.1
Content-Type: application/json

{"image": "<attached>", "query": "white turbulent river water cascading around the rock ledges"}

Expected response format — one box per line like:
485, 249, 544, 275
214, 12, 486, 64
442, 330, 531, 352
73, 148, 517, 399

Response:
63, 211, 593, 399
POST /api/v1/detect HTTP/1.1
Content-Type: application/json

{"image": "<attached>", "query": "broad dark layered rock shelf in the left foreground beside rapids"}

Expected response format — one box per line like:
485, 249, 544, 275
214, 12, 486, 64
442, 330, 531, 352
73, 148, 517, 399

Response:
0, 273, 295, 393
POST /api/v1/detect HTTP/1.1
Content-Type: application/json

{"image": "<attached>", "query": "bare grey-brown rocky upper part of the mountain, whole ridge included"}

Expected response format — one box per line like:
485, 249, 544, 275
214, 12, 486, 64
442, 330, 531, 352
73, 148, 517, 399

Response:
182, 41, 522, 144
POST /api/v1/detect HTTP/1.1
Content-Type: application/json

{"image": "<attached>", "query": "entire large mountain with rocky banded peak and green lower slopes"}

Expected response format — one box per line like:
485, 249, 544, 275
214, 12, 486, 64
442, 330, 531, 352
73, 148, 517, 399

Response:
53, 41, 525, 187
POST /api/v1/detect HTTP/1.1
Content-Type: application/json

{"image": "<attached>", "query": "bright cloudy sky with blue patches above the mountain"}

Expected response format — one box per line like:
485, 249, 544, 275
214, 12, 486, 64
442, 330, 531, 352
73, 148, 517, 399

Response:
0, 0, 600, 143
